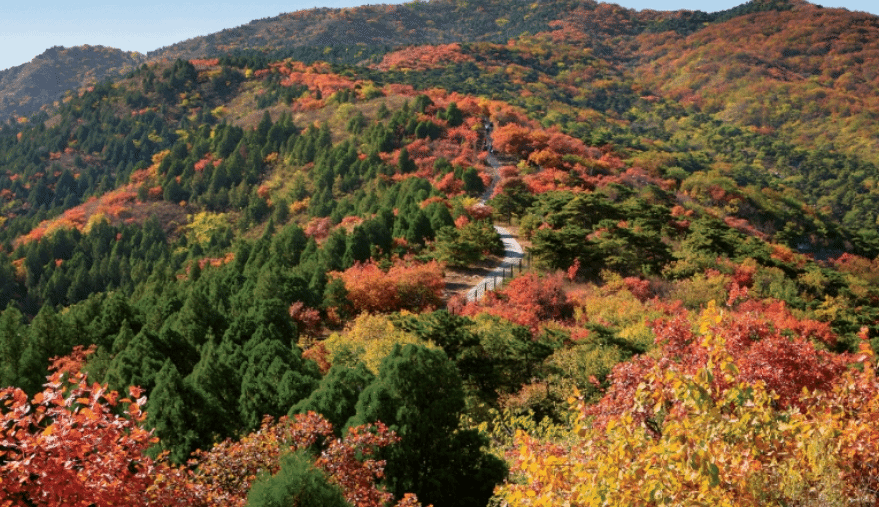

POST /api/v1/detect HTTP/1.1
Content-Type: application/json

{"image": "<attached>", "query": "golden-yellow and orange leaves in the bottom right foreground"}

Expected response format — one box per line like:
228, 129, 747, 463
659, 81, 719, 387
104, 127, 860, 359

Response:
496, 304, 879, 507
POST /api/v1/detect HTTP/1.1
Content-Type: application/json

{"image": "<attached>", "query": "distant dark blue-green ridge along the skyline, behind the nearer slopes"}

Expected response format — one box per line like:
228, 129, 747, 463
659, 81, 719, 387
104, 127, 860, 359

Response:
0, 0, 789, 121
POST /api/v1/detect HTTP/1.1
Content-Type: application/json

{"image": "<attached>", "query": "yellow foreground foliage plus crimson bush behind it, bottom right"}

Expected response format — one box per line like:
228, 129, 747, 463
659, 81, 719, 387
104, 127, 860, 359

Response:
499, 304, 879, 506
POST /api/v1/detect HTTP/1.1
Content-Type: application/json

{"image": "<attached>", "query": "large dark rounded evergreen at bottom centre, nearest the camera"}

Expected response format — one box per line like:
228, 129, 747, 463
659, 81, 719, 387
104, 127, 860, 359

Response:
347, 344, 507, 507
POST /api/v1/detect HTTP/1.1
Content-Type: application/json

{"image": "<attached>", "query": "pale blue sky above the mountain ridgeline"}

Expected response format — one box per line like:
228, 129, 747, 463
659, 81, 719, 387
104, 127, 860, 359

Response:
0, 0, 879, 70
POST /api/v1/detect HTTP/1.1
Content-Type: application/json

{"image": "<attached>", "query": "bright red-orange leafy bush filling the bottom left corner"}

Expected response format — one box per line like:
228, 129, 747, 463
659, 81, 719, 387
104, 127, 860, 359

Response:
0, 372, 155, 507
